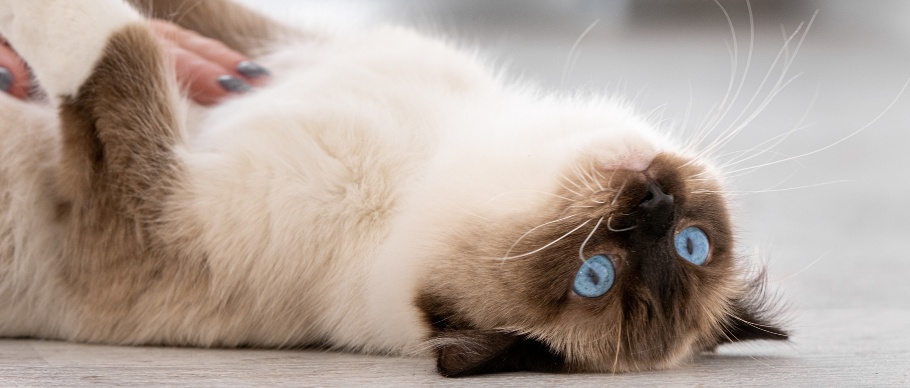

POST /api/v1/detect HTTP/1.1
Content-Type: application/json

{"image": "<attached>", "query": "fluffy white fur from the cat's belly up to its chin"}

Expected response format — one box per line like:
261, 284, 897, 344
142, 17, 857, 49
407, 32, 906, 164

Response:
180, 29, 657, 353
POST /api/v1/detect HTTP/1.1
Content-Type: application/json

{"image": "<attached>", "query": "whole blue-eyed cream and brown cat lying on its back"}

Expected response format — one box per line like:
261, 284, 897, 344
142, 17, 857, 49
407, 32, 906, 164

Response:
0, 0, 787, 376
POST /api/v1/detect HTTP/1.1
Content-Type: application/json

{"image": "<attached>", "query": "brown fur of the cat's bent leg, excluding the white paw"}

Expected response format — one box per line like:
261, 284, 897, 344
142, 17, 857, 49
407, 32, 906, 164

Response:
58, 26, 214, 336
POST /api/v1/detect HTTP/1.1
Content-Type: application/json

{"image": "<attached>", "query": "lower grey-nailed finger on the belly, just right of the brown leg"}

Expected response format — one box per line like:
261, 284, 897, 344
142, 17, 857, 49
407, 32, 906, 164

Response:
166, 46, 250, 105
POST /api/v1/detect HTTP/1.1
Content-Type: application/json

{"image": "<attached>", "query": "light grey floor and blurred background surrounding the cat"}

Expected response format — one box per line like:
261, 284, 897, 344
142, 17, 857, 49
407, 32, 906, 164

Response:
0, 0, 910, 386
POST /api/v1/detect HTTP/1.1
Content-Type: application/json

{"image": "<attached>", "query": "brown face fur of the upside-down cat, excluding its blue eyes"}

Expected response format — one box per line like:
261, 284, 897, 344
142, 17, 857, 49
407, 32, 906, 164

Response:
416, 154, 779, 372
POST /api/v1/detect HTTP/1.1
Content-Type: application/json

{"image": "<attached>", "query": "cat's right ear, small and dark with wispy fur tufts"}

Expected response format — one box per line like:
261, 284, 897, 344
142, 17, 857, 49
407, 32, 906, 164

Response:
718, 298, 790, 344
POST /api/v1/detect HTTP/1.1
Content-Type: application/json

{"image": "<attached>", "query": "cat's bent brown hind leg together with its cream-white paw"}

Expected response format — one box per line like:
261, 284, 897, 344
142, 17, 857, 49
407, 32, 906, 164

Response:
0, 0, 190, 336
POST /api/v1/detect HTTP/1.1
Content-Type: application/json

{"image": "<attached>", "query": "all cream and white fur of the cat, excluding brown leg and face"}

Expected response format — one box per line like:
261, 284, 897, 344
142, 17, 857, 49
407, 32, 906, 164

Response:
0, 0, 728, 364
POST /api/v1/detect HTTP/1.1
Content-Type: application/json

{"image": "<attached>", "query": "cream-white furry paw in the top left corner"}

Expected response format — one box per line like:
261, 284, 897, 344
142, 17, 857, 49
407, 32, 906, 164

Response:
0, 0, 143, 97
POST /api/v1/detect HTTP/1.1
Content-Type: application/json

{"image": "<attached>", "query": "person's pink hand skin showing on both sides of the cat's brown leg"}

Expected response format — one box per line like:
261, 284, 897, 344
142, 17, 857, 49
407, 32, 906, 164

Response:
0, 20, 268, 105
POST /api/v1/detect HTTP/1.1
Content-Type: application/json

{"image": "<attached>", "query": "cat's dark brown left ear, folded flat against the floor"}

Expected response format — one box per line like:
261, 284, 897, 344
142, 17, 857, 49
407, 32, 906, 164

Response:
436, 330, 565, 377
